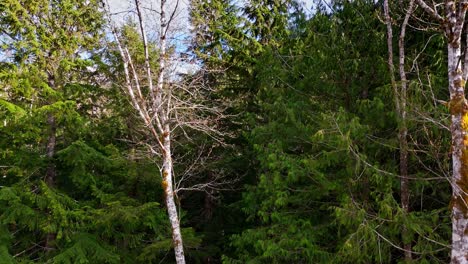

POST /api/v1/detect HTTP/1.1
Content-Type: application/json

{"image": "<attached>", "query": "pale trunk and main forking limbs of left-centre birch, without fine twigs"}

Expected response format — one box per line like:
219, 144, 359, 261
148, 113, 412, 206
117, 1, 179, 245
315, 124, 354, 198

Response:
109, 0, 185, 264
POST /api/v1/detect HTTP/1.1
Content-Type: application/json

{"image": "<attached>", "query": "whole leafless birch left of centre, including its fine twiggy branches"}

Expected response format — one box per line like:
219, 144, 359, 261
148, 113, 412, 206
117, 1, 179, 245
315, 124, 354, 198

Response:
104, 0, 227, 264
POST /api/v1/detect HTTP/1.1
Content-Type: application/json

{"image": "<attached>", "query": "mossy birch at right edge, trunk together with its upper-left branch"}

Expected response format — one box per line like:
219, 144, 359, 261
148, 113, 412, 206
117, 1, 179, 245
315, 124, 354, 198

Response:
416, 0, 468, 263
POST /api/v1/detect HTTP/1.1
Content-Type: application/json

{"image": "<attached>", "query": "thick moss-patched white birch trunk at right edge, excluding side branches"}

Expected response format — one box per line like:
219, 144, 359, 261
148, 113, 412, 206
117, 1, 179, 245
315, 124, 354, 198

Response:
445, 1, 468, 263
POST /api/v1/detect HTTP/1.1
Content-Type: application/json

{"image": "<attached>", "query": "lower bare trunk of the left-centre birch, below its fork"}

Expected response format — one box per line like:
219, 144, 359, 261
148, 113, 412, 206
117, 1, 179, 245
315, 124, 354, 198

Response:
162, 126, 185, 264
